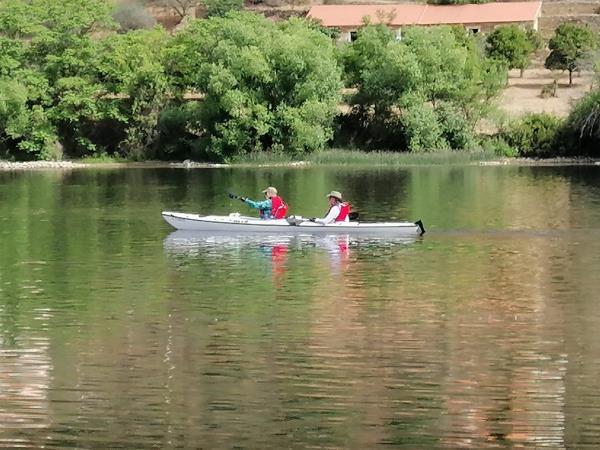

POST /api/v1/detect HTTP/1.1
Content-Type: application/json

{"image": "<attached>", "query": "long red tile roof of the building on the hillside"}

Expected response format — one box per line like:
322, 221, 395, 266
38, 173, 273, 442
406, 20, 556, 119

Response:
308, 1, 542, 28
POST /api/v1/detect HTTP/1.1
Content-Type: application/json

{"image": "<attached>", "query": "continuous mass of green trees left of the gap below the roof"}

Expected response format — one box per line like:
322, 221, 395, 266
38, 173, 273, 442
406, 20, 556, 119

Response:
0, 0, 341, 159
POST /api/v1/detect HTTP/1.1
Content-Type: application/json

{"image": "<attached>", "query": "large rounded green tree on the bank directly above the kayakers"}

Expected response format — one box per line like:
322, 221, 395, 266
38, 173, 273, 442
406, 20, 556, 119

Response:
167, 13, 341, 159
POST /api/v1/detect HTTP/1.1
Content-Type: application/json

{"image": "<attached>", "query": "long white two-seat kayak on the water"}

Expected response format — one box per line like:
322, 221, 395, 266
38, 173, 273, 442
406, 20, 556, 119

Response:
162, 211, 425, 236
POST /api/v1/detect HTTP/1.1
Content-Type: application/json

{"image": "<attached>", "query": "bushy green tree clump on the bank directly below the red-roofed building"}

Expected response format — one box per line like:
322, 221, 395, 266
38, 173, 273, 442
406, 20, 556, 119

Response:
341, 25, 506, 151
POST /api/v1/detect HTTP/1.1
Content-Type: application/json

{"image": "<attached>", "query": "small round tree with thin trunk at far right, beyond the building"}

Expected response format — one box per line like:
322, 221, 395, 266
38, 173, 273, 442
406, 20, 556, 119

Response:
545, 23, 597, 85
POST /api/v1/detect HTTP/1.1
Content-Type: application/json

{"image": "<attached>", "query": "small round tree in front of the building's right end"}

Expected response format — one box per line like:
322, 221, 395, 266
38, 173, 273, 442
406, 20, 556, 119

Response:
486, 25, 535, 76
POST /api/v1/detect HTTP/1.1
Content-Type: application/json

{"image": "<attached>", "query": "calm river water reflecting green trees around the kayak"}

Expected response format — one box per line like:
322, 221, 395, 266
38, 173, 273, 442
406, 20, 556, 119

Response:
0, 166, 600, 449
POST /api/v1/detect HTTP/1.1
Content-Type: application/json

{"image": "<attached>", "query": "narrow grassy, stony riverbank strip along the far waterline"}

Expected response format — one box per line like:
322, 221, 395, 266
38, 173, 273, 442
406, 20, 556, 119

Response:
0, 150, 600, 171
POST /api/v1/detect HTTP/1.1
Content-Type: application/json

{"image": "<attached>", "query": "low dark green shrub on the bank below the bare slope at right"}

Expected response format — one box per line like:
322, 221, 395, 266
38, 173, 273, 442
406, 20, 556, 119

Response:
501, 113, 563, 157
